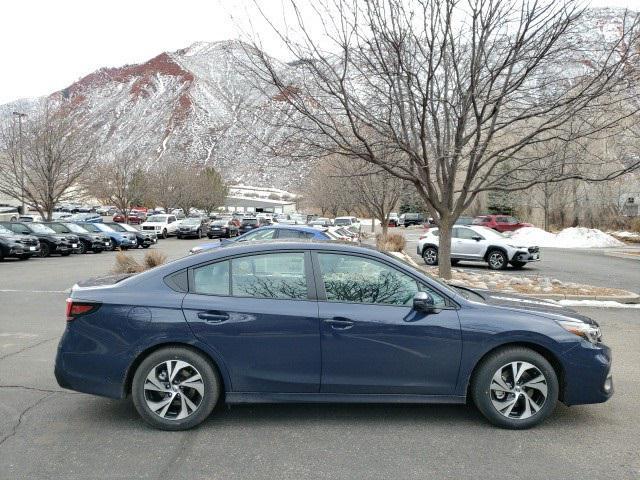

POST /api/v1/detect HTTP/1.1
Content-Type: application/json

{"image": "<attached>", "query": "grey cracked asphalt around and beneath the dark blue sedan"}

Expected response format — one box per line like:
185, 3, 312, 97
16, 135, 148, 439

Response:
0, 238, 640, 479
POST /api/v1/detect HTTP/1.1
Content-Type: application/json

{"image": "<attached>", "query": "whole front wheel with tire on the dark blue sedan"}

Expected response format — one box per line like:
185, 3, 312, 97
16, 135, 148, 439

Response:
470, 347, 558, 429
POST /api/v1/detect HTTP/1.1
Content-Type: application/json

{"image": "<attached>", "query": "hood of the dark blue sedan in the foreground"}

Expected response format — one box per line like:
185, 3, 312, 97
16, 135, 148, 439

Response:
476, 291, 598, 325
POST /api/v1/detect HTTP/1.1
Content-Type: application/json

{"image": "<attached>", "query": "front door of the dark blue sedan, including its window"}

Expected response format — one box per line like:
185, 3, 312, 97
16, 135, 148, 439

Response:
314, 252, 461, 395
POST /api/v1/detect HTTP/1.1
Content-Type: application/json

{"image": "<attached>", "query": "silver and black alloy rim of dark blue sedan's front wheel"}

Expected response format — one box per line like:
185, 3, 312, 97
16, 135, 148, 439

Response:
489, 362, 548, 420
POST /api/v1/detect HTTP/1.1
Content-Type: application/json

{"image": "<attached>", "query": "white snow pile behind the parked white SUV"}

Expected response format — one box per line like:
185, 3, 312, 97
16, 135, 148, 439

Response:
511, 227, 624, 248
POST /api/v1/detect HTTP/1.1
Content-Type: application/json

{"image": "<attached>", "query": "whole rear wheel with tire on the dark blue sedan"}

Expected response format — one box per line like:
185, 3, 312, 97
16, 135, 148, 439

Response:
131, 347, 221, 430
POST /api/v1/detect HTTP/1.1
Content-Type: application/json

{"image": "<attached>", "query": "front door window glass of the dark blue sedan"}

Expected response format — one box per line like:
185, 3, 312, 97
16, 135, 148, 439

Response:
318, 253, 418, 305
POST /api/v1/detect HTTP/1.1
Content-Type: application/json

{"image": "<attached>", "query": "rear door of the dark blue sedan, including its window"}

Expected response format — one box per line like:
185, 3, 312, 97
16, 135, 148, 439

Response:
183, 252, 320, 393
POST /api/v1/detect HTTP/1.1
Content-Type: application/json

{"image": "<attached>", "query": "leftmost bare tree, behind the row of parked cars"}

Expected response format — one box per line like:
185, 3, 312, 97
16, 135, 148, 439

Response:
0, 100, 96, 220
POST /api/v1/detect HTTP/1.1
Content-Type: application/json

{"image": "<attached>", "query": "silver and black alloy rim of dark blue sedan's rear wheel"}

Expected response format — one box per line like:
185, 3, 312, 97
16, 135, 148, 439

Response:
143, 360, 205, 420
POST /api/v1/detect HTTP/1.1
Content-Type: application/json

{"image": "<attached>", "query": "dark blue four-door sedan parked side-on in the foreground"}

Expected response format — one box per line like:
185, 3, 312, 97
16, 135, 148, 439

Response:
55, 241, 613, 430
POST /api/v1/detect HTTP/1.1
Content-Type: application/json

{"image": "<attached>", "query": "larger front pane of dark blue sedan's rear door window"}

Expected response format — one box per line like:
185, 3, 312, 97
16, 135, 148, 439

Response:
231, 253, 308, 300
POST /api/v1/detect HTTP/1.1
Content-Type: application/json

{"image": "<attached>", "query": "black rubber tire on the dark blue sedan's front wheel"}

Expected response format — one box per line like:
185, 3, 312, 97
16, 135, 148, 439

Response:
470, 347, 559, 430
